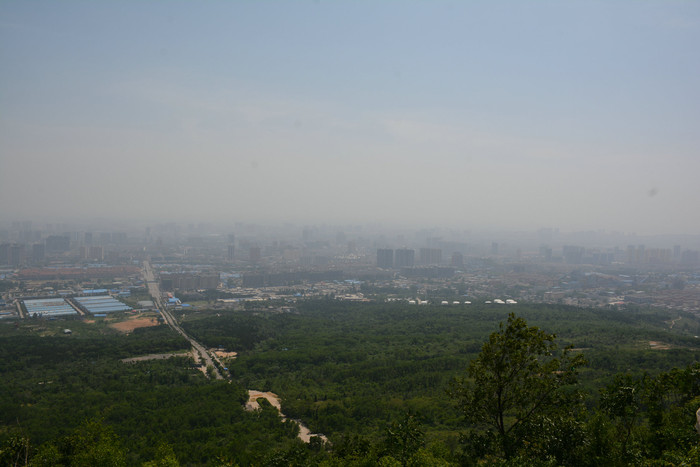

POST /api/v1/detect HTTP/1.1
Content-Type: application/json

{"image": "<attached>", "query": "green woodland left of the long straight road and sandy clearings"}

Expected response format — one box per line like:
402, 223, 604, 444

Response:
0, 321, 306, 465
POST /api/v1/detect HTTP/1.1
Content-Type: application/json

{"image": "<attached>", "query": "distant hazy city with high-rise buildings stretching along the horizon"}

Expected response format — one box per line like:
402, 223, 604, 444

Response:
0, 221, 700, 318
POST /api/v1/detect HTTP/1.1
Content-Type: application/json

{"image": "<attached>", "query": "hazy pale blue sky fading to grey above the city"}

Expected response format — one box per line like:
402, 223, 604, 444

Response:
0, 0, 700, 235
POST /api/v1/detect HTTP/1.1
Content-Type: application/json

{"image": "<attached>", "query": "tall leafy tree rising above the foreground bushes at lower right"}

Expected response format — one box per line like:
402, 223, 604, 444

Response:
450, 313, 586, 459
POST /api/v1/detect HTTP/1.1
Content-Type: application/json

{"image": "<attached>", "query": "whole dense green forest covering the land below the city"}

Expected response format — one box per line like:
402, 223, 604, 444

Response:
0, 300, 700, 466
